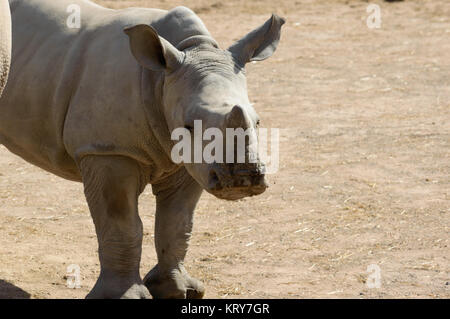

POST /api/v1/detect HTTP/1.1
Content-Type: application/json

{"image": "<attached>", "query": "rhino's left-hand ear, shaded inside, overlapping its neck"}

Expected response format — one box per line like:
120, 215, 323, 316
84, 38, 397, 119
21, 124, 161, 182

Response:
124, 24, 184, 71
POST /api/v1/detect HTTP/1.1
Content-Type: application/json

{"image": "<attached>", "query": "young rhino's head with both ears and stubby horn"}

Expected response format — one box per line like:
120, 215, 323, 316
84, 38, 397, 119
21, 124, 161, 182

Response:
125, 15, 285, 200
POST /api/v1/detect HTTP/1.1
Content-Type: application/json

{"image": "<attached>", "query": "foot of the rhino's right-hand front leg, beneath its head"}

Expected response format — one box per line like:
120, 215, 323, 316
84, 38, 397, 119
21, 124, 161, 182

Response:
144, 265, 205, 299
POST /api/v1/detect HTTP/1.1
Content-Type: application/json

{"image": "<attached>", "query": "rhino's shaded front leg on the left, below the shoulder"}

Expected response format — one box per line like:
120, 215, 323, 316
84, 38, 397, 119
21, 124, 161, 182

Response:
80, 156, 150, 299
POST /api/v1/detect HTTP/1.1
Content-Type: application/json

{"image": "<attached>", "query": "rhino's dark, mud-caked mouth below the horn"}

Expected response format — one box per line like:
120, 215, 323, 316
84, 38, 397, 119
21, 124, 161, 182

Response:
207, 167, 268, 200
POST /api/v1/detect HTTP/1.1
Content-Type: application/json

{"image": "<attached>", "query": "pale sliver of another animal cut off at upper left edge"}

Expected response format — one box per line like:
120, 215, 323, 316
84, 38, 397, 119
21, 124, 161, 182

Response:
0, 0, 11, 97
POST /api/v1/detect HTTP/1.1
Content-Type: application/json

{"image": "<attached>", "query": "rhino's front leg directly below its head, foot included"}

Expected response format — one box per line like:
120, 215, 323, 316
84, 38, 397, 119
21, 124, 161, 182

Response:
144, 169, 205, 299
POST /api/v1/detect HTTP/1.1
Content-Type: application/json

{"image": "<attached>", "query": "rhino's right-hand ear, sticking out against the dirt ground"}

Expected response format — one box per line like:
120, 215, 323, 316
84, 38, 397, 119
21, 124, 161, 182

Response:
228, 14, 285, 65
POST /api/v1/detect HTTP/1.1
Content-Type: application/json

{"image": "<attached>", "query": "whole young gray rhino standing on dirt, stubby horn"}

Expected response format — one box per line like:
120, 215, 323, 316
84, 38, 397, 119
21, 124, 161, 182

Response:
0, 0, 284, 298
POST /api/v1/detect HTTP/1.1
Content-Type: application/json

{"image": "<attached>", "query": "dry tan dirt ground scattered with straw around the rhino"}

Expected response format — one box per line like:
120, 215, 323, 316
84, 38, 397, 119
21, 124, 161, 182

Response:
0, 0, 450, 298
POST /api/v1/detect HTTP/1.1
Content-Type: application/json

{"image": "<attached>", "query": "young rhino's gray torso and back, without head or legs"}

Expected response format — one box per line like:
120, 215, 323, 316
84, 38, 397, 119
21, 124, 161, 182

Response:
0, 0, 207, 180
